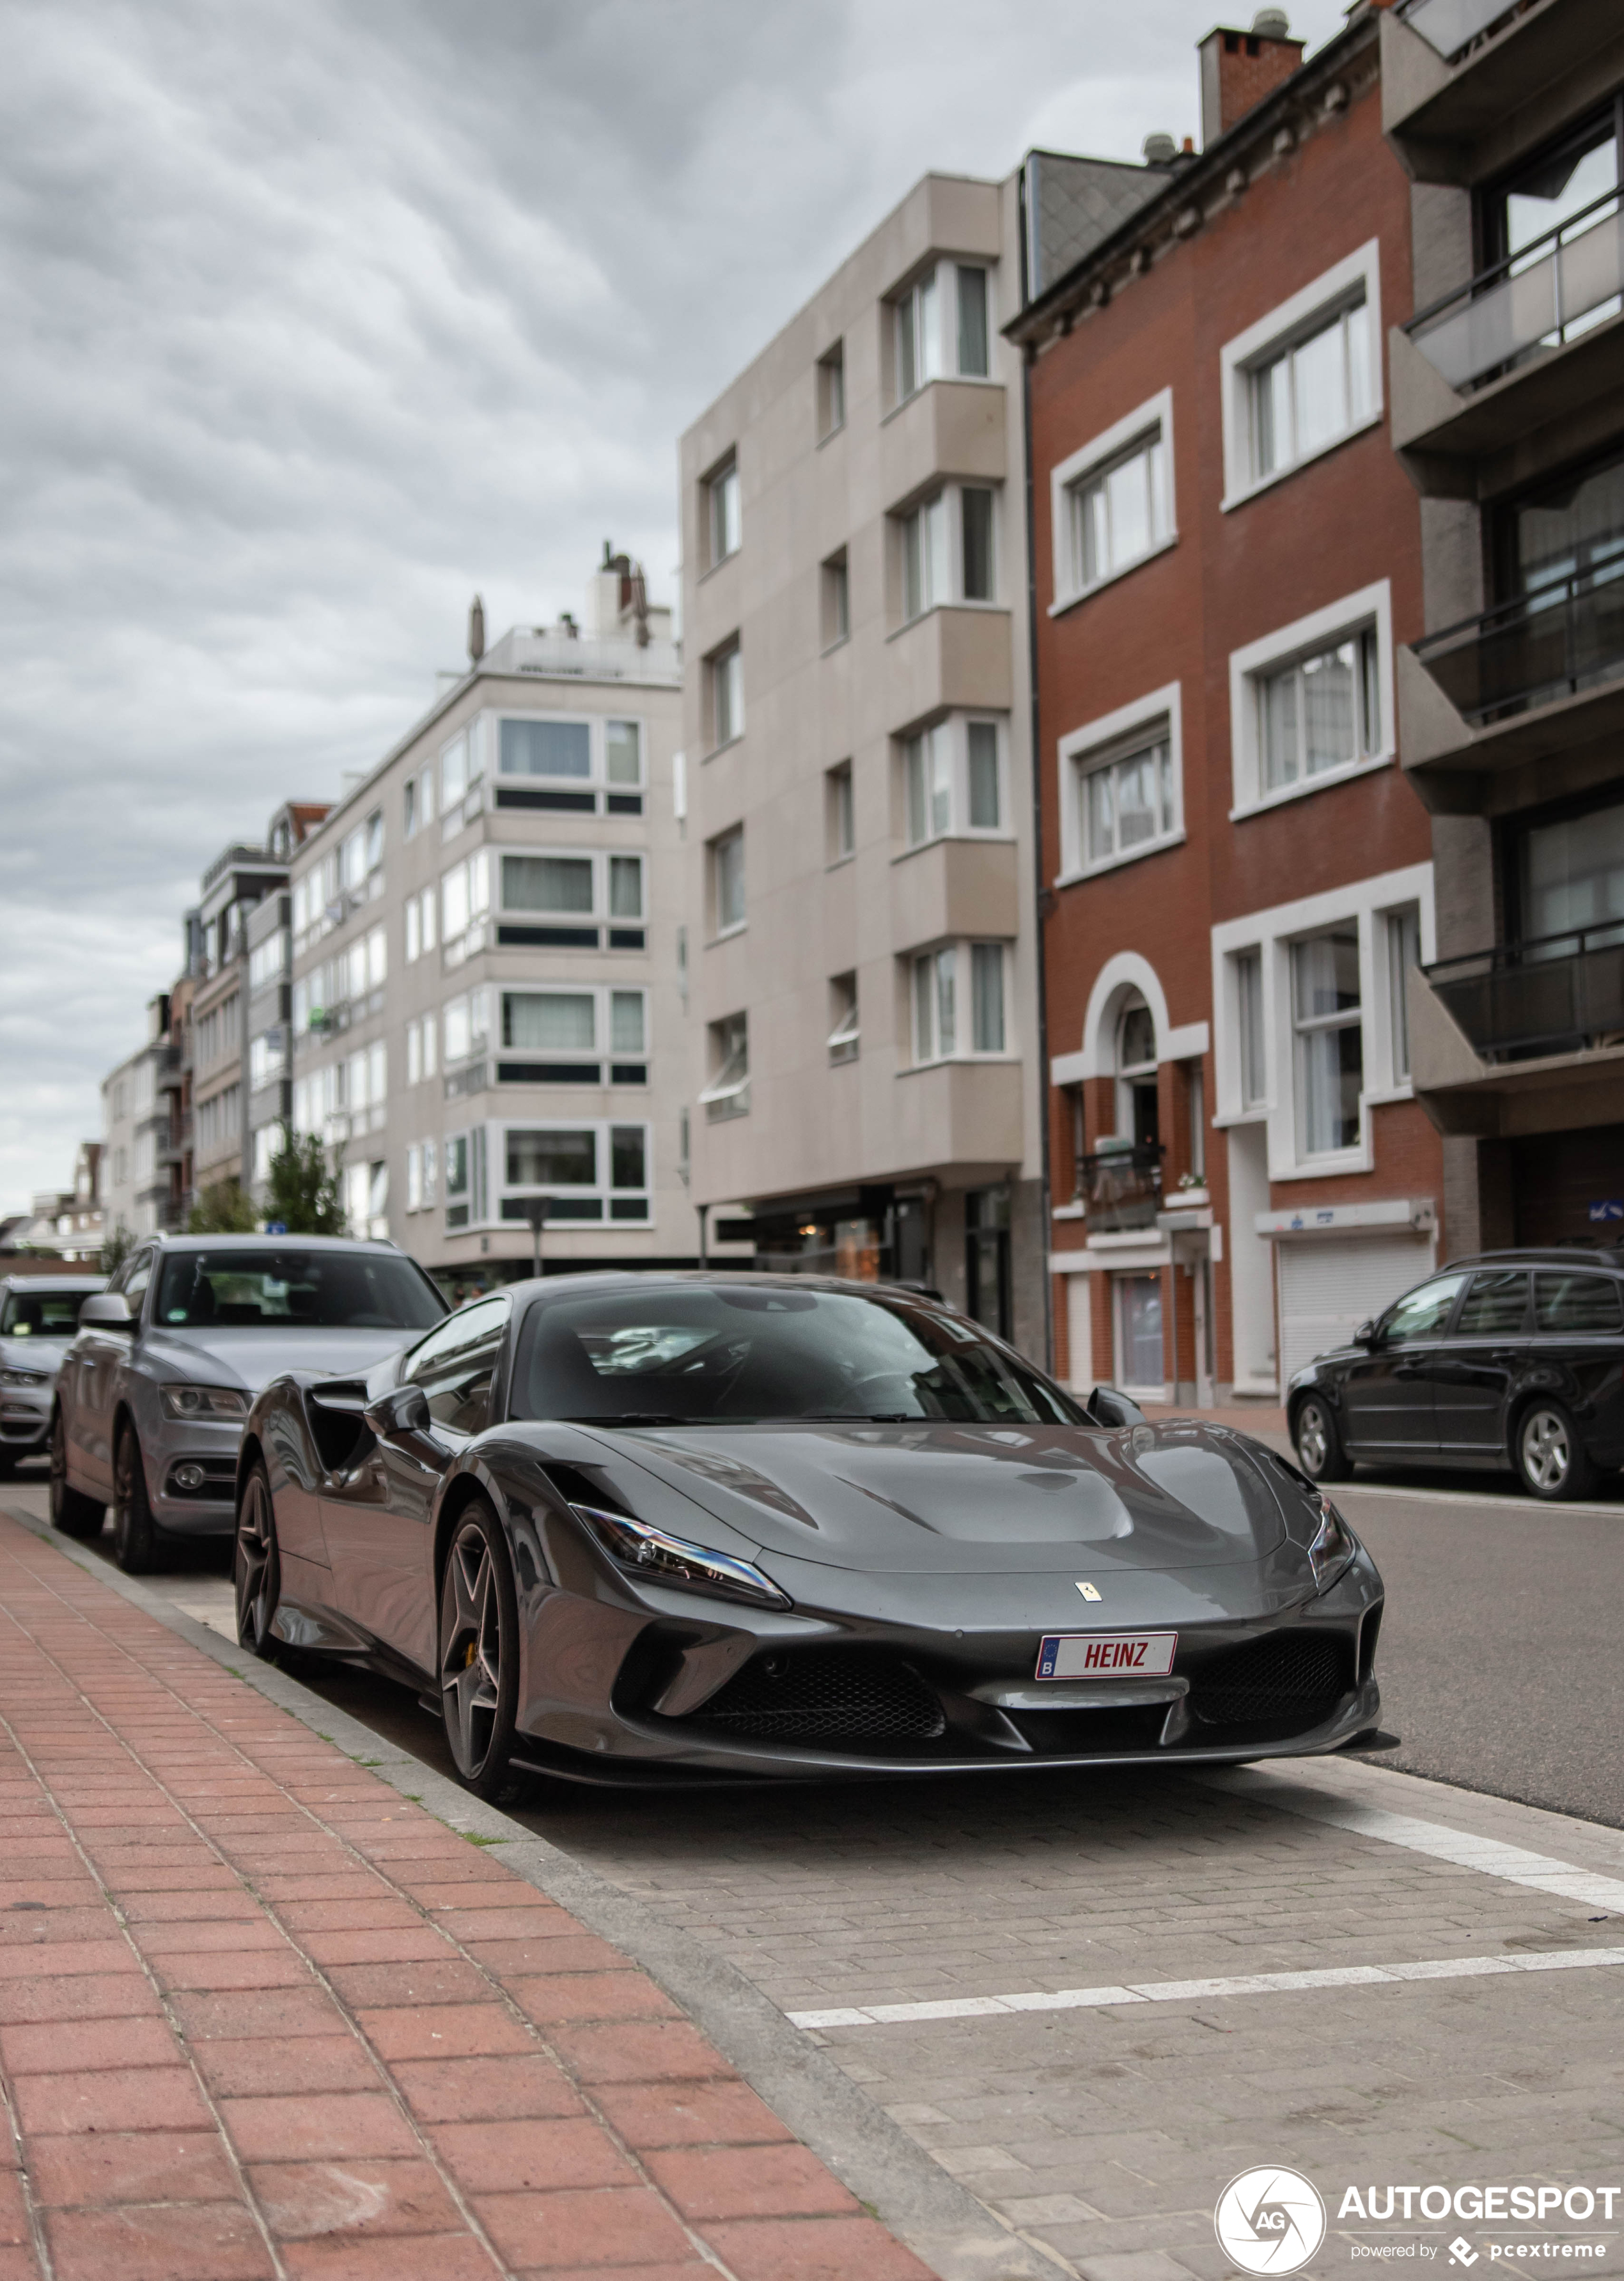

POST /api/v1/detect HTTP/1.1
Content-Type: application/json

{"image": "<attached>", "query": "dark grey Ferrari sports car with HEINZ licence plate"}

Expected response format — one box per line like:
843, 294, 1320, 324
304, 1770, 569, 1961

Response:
235, 1273, 1382, 1798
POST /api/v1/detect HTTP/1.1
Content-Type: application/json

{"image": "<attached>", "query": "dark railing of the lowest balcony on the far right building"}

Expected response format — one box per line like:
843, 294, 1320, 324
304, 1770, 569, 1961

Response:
1423, 919, 1624, 1061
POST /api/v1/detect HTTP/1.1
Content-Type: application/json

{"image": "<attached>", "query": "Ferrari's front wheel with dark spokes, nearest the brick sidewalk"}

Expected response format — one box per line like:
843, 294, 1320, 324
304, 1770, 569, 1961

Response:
438, 1499, 525, 1807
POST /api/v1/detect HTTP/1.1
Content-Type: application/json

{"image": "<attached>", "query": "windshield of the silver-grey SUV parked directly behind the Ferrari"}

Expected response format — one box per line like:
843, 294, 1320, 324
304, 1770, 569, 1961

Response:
153, 1248, 445, 1330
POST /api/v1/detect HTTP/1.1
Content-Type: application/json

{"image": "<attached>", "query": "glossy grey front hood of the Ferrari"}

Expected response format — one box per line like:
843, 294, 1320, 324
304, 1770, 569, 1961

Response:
604, 1423, 1284, 1576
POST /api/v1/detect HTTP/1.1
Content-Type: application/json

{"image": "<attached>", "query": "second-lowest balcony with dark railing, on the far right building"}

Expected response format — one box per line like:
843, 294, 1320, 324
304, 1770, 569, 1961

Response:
1398, 559, 1624, 814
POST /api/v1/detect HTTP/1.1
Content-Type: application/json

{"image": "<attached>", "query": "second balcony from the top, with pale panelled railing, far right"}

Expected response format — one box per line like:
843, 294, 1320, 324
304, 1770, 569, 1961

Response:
1389, 191, 1624, 497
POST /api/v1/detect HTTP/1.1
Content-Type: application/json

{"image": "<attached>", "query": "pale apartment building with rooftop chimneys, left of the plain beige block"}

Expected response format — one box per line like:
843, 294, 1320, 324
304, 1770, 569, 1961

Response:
290, 550, 698, 1291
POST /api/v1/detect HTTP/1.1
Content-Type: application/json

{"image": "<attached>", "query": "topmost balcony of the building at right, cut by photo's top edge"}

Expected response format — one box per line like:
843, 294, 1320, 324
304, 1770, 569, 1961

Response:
1382, 0, 1624, 182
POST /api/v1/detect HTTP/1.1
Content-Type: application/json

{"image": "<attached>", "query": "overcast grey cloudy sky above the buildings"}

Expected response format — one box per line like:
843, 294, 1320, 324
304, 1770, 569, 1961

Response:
0, 0, 1341, 1211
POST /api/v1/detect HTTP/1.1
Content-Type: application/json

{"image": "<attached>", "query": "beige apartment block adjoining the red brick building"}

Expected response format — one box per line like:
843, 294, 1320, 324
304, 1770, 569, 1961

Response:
680, 176, 1047, 1355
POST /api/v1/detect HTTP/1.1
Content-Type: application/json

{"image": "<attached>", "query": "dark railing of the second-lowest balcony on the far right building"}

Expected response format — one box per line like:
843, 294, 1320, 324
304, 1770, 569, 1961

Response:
1414, 559, 1624, 726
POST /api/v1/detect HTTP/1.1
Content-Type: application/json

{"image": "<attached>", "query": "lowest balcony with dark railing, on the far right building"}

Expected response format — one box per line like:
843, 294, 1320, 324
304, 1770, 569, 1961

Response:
1407, 921, 1624, 1136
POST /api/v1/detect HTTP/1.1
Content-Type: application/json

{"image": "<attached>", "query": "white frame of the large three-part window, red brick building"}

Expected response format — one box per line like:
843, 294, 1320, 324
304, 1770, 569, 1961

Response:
1211, 862, 1437, 1179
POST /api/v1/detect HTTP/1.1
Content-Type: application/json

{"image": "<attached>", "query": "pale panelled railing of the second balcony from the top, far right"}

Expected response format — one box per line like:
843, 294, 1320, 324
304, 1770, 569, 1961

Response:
1405, 194, 1624, 390
